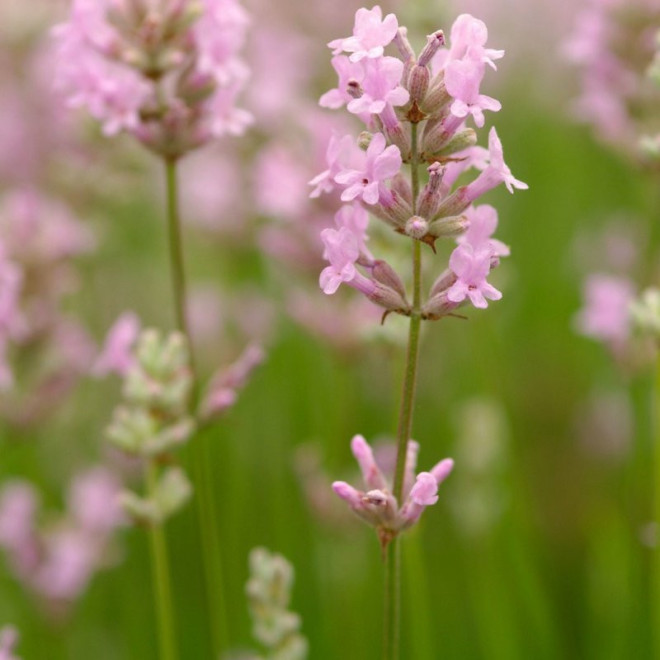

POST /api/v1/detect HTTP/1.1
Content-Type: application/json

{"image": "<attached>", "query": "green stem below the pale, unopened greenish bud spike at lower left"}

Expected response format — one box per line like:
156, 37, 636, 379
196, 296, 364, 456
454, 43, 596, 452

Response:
146, 461, 178, 660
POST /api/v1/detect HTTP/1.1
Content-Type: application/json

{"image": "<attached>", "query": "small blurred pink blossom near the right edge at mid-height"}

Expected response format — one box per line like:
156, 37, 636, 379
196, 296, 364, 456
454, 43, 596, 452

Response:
576, 274, 635, 349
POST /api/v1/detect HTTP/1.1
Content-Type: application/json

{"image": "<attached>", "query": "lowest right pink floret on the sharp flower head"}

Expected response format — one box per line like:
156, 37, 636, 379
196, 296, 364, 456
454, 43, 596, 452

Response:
447, 244, 502, 309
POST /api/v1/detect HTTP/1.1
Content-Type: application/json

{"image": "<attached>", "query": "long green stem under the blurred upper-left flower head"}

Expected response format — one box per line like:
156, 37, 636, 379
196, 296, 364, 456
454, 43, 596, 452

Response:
165, 159, 227, 657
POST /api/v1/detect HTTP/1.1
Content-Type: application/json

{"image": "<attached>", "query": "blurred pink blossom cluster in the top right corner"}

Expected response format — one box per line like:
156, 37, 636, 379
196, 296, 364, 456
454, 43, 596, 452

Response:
564, 0, 660, 152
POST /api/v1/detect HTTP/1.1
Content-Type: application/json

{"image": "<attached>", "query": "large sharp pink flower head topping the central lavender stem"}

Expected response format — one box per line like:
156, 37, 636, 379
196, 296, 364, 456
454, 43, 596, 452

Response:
310, 6, 527, 320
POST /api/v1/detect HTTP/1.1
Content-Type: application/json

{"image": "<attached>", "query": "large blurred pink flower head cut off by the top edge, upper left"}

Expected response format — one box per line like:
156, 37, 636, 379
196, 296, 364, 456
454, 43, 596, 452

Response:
54, 0, 251, 158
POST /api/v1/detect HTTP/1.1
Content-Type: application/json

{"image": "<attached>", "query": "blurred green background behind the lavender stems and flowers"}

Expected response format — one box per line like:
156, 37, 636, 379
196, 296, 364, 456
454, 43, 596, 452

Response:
0, 0, 658, 660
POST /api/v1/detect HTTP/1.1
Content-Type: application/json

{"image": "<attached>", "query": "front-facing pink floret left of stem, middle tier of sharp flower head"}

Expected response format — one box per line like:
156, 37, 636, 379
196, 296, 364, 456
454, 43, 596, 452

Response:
335, 133, 402, 204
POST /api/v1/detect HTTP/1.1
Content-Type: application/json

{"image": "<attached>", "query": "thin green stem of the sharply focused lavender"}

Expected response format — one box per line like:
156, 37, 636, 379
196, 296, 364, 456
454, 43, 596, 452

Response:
384, 123, 422, 660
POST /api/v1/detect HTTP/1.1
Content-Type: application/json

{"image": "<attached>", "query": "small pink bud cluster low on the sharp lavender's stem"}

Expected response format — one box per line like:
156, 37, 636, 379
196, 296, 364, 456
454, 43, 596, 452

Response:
332, 435, 454, 545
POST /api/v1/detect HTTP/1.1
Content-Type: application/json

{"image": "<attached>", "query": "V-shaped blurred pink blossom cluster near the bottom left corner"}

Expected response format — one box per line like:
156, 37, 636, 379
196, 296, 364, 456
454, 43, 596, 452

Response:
0, 467, 123, 608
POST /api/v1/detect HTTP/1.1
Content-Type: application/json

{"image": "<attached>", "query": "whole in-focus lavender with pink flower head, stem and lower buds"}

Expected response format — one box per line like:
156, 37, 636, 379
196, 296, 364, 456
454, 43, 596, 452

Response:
310, 6, 527, 659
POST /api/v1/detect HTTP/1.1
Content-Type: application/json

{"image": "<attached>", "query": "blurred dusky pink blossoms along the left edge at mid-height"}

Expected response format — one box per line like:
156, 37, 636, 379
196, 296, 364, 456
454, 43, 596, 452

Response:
0, 189, 94, 423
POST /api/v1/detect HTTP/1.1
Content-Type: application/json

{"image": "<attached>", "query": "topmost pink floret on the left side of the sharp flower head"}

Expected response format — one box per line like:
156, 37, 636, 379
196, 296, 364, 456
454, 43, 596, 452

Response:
328, 5, 399, 62
